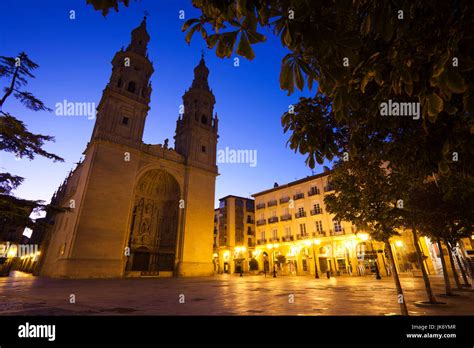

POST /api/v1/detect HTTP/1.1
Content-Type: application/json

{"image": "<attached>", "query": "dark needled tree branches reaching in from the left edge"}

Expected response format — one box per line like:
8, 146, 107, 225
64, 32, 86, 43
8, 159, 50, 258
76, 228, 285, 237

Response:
0, 52, 63, 234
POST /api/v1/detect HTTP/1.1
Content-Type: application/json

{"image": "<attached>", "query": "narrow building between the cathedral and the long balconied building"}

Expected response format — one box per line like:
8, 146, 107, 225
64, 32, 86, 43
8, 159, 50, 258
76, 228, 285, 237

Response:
214, 195, 255, 273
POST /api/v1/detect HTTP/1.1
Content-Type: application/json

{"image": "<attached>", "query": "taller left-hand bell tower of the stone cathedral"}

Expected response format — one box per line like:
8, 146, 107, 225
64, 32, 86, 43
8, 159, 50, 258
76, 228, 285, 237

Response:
92, 17, 154, 142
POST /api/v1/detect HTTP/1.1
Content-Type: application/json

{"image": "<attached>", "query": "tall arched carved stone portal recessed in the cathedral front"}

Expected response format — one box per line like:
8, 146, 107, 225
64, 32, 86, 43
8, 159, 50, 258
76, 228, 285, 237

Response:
127, 170, 180, 272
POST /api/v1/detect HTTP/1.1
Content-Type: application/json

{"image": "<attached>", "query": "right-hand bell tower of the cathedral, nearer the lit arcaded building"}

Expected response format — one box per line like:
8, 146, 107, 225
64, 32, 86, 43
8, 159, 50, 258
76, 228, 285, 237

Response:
174, 56, 218, 169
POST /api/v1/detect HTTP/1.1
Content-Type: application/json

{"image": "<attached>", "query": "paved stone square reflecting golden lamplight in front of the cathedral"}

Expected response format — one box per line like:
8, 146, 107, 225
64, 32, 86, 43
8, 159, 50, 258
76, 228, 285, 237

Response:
0, 273, 474, 315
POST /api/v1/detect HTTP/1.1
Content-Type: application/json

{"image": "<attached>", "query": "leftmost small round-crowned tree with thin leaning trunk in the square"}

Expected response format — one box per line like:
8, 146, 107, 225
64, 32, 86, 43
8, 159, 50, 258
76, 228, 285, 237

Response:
324, 158, 408, 315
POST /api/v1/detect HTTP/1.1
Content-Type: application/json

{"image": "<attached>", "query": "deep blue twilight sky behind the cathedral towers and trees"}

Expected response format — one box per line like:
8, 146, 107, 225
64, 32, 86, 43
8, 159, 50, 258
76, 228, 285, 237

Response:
0, 0, 334, 209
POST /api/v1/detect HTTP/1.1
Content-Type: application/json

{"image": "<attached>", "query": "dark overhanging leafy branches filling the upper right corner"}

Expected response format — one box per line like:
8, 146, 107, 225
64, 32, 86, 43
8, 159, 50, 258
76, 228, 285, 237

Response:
187, 0, 474, 173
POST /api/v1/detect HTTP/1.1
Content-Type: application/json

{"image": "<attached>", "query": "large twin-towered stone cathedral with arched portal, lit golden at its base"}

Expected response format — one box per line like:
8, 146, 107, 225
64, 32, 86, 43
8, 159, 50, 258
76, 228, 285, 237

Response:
39, 18, 218, 278
